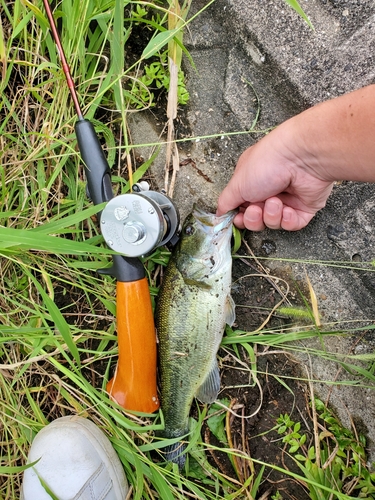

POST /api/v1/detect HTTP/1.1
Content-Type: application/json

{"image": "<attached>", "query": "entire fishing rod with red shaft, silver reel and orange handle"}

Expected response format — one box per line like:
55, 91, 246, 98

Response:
43, 0, 179, 413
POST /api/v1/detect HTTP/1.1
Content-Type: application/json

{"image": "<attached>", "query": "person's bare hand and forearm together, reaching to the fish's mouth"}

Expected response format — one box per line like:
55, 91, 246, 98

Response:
217, 85, 375, 231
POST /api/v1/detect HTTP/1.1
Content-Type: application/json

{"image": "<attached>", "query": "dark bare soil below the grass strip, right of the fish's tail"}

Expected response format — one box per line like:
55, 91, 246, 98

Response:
219, 352, 311, 500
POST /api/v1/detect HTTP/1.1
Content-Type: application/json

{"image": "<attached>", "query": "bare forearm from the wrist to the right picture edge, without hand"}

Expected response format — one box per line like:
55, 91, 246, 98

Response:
290, 85, 375, 182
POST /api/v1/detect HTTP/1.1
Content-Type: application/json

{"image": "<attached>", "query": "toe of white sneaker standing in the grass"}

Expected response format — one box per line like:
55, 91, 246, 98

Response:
21, 416, 129, 500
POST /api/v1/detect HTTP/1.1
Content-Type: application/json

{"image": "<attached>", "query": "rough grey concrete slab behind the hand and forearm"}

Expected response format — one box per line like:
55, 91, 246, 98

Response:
131, 0, 375, 459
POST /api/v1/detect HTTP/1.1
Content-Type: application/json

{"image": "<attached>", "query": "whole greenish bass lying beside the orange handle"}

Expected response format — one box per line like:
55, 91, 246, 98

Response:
155, 205, 237, 469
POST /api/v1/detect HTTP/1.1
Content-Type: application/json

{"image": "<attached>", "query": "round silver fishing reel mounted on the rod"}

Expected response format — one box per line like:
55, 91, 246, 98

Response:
100, 187, 180, 257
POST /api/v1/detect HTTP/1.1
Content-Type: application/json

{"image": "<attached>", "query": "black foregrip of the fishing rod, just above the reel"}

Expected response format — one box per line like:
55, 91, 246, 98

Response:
75, 119, 113, 205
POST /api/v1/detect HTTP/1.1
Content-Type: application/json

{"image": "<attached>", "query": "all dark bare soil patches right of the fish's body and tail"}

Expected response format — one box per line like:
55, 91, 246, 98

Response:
213, 249, 312, 500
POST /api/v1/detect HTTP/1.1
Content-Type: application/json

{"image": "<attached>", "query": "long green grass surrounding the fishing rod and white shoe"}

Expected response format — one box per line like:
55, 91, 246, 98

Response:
0, 0, 374, 500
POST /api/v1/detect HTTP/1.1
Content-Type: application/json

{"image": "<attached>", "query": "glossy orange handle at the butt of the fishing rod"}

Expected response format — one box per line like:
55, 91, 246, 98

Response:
107, 278, 160, 413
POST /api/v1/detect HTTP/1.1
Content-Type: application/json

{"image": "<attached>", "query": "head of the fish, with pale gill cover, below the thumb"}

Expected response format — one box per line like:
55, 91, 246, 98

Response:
177, 205, 237, 281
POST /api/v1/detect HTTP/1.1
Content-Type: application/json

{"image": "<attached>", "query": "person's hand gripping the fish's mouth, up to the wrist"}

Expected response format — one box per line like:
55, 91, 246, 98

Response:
217, 119, 333, 231
